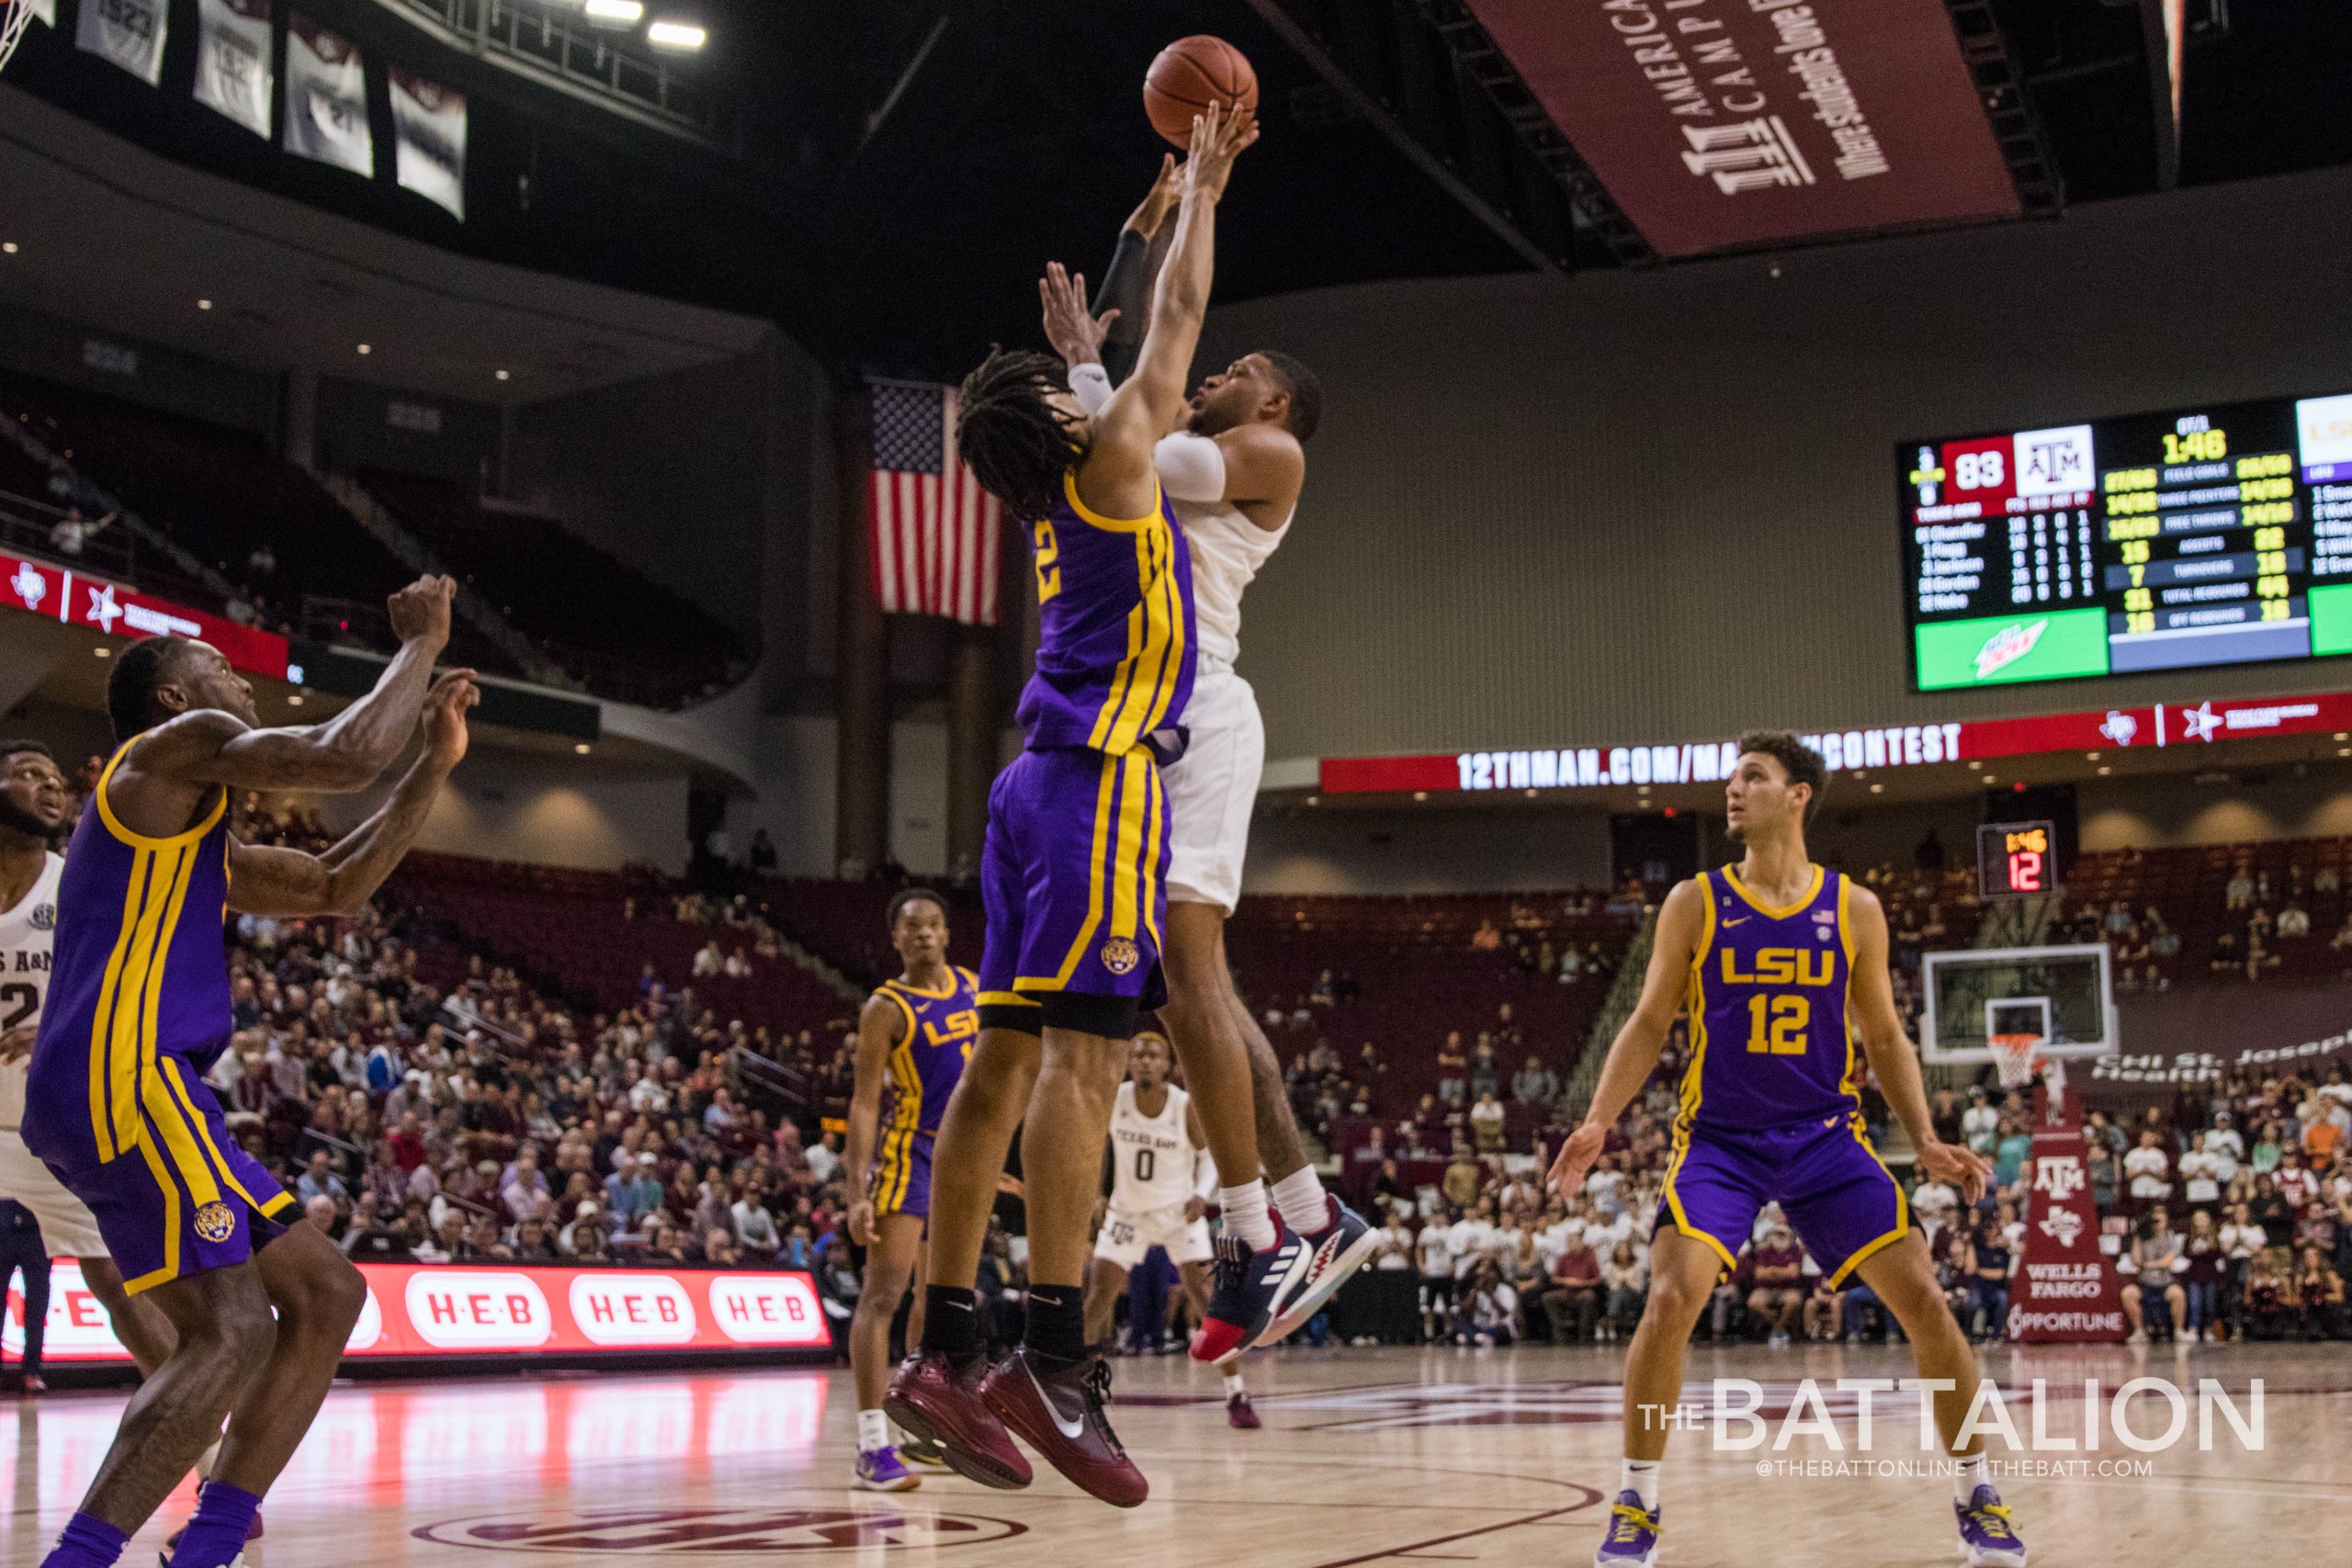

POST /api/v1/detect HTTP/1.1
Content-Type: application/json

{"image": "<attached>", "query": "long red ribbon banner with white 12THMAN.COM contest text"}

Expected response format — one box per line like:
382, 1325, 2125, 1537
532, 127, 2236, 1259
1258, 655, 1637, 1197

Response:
1319, 691, 2352, 795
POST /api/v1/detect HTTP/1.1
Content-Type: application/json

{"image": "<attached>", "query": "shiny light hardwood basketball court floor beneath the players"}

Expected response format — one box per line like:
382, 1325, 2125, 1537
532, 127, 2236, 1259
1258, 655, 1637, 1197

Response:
0, 1345, 2352, 1568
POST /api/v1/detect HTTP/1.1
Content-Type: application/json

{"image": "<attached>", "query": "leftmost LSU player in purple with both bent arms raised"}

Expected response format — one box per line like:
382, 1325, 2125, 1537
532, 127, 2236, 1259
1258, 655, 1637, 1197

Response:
24, 579, 480, 1568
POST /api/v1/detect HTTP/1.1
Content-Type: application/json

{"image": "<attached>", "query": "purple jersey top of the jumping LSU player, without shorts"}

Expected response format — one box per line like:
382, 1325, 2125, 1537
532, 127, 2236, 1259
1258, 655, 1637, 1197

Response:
1021, 470, 1197, 761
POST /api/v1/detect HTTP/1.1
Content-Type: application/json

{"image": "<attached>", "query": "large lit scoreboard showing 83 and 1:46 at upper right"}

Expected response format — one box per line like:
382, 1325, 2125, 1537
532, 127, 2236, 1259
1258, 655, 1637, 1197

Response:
1895, 395, 2352, 691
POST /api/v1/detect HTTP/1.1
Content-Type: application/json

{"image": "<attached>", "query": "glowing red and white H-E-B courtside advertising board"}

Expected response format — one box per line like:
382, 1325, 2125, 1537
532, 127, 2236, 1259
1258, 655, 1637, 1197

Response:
0, 1258, 832, 1363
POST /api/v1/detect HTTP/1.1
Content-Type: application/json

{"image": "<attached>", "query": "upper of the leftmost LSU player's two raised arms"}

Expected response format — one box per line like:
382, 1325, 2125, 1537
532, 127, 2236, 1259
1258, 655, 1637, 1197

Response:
140, 576, 473, 795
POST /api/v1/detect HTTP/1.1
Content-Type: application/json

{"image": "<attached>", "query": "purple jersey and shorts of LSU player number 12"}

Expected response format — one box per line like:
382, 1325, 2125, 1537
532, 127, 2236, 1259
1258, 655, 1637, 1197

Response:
1658, 865, 1910, 1286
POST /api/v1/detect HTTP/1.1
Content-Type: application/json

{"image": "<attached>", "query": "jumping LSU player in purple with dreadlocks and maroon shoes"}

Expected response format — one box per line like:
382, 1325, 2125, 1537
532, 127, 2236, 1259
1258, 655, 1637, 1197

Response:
885, 108, 1303, 1506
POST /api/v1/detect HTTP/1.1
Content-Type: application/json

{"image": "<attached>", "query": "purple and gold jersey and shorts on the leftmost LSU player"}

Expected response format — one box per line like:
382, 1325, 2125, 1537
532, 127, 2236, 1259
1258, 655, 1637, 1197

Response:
24, 740, 294, 1293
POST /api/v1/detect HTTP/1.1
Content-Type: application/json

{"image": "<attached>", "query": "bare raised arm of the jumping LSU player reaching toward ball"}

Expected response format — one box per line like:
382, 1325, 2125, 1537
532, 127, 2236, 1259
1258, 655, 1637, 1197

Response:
1077, 104, 1259, 517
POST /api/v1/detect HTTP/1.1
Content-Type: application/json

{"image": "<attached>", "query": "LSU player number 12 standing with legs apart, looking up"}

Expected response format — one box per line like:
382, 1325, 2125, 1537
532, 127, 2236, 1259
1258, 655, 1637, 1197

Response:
1553, 731, 2025, 1568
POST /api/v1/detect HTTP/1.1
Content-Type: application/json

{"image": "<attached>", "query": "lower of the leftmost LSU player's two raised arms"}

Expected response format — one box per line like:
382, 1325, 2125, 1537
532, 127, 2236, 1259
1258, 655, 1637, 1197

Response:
228, 672, 482, 919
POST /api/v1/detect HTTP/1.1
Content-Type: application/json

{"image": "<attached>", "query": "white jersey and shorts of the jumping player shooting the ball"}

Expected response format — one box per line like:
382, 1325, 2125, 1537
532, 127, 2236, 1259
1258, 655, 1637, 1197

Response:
1159, 501, 1296, 915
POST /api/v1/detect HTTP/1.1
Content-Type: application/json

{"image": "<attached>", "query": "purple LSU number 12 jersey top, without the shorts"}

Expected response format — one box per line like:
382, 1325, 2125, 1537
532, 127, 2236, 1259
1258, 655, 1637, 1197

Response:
1675, 865, 1863, 1135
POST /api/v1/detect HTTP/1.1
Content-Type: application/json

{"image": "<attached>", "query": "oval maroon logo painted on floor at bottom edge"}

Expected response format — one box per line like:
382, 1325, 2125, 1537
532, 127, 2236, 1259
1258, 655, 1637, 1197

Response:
409, 1505, 1028, 1559
